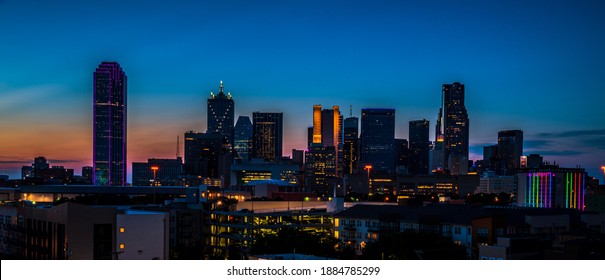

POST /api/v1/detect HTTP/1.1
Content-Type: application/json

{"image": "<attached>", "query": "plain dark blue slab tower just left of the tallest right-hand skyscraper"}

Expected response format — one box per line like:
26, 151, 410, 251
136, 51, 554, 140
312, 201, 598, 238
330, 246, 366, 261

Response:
408, 119, 430, 174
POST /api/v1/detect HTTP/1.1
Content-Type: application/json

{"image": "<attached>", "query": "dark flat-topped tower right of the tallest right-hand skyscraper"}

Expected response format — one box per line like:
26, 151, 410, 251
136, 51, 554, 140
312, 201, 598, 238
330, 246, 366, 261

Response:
496, 130, 523, 175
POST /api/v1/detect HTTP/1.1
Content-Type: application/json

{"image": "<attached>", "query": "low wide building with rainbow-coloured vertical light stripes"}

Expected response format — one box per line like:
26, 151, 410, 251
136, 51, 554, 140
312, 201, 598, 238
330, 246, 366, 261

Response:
517, 166, 586, 210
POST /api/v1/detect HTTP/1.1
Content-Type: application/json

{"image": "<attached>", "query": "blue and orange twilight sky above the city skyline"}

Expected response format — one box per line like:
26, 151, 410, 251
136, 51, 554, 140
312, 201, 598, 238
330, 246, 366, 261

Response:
0, 0, 605, 182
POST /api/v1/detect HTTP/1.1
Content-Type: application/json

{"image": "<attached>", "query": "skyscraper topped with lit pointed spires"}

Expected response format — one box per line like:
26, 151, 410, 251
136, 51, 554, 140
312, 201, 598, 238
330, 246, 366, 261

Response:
207, 81, 235, 147
